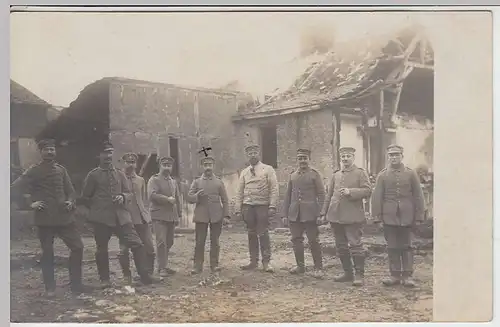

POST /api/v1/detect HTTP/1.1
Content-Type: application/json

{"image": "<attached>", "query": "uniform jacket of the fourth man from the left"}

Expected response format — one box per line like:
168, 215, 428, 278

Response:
148, 174, 182, 221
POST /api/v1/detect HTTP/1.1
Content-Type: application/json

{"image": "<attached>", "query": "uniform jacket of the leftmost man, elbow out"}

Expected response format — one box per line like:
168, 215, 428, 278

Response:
11, 162, 76, 226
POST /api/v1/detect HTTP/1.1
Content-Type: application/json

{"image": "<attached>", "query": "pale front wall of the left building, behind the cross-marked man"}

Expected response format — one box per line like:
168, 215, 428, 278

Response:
110, 83, 241, 181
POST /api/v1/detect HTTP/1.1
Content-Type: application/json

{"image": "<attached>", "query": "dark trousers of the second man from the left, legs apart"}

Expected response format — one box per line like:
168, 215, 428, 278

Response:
94, 223, 149, 282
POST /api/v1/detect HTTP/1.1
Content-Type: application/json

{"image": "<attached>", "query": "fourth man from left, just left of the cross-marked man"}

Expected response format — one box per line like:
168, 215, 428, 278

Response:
148, 156, 182, 277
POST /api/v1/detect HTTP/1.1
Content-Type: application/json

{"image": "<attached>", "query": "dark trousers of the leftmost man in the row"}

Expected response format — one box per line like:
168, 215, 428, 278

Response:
38, 223, 83, 290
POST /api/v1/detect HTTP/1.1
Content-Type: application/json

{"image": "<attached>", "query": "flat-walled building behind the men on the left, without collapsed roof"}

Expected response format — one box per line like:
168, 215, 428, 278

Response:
39, 77, 256, 227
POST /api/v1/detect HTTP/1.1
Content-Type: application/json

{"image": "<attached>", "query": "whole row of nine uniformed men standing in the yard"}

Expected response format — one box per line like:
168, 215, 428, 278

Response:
11, 139, 424, 297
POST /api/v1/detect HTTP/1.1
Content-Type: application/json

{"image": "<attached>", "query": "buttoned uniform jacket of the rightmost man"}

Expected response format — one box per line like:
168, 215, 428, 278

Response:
371, 165, 425, 226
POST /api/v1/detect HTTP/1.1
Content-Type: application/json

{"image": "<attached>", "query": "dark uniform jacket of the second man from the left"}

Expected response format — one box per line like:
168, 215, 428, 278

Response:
82, 167, 133, 226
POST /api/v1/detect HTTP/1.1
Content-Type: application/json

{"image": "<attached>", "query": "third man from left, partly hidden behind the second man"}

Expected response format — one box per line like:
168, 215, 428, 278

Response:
118, 153, 155, 284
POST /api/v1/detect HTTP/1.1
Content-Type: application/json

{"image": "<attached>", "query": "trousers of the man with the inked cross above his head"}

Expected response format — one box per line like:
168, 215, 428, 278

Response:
194, 221, 222, 269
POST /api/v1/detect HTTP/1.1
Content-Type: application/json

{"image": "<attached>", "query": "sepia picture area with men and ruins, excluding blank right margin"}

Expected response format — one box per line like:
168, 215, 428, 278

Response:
6, 9, 492, 323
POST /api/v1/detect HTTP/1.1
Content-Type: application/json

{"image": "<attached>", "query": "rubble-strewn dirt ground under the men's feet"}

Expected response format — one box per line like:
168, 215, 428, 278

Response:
11, 230, 433, 323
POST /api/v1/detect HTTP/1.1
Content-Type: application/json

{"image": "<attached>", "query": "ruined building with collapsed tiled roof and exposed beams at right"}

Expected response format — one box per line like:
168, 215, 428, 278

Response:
233, 27, 434, 219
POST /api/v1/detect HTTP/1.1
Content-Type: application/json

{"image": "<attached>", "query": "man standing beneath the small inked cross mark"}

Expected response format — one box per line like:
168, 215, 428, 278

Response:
188, 157, 229, 275
